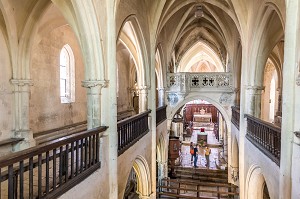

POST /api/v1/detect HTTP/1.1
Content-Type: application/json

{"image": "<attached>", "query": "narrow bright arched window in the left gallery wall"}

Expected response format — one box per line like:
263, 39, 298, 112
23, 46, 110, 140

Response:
59, 44, 75, 103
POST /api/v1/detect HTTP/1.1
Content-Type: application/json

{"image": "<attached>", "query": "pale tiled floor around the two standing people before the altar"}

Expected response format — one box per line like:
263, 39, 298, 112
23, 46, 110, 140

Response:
179, 127, 220, 169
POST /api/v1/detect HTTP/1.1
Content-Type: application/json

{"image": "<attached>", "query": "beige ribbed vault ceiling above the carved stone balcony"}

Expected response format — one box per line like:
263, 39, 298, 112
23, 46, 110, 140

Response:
158, 0, 240, 71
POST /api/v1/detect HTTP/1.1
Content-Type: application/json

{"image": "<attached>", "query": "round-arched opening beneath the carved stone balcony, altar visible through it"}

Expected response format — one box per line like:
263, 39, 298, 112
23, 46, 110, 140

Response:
168, 97, 231, 169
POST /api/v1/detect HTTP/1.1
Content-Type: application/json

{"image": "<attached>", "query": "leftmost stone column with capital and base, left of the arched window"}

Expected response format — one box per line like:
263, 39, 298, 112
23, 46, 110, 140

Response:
11, 79, 35, 151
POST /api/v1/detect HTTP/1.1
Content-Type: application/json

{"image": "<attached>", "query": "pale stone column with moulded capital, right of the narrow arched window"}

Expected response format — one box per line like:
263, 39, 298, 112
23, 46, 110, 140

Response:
82, 80, 107, 129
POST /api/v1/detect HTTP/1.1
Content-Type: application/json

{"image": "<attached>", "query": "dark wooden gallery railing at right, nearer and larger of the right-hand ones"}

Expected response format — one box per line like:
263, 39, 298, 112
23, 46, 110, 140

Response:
245, 115, 281, 166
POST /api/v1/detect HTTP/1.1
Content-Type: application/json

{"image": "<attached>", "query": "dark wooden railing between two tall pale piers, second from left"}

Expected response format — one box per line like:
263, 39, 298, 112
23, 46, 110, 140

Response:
117, 110, 151, 155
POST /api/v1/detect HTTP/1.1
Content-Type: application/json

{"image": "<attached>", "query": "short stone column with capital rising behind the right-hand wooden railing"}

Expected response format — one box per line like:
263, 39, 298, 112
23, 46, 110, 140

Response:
246, 86, 264, 118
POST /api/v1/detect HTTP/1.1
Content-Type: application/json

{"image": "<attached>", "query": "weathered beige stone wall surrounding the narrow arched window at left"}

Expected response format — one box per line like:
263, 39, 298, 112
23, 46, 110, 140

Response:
29, 25, 87, 133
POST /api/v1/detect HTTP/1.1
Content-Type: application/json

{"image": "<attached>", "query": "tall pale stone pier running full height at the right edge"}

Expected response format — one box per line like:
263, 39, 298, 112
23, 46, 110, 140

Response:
279, 0, 300, 199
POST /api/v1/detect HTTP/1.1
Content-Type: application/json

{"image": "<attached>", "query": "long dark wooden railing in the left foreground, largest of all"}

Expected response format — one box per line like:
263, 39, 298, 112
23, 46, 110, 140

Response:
0, 127, 107, 199
